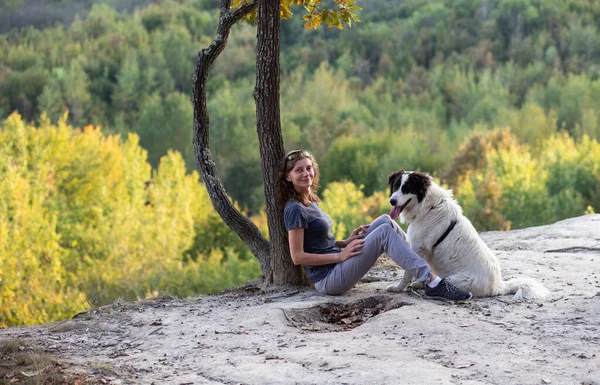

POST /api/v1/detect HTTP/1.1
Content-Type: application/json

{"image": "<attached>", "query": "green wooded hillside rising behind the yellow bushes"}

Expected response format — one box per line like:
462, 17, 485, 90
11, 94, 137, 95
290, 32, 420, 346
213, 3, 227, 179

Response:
0, 0, 600, 216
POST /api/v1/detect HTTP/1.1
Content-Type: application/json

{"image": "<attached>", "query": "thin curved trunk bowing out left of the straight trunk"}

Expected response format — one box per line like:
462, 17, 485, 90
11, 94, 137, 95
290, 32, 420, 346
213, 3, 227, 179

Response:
192, 0, 272, 280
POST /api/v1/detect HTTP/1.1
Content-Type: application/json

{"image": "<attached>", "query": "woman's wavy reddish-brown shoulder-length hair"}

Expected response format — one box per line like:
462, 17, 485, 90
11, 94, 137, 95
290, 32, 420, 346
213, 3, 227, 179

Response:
277, 150, 320, 208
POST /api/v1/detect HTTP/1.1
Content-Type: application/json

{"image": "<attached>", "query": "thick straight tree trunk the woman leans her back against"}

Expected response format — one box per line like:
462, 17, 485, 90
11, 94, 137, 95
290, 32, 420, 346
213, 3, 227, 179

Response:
254, 0, 305, 285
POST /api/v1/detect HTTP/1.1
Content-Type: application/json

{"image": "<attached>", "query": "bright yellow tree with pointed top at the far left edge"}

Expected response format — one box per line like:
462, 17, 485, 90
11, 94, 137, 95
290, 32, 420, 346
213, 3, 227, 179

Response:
0, 114, 85, 327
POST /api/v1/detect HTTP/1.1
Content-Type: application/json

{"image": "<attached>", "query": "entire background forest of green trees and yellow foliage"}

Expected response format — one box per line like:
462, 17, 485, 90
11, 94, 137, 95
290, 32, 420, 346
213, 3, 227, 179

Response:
0, 0, 600, 327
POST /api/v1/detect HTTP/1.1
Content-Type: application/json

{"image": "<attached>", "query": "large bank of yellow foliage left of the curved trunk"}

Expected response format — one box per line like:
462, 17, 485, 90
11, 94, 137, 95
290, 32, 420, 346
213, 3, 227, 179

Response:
0, 114, 260, 327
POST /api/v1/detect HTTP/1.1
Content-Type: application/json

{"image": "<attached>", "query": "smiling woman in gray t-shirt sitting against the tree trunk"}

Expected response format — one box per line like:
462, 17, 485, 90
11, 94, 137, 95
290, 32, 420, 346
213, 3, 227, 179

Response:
277, 150, 471, 301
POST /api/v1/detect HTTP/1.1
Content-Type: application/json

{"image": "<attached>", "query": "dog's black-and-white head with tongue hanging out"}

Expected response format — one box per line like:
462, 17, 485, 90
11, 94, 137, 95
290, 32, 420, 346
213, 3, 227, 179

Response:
388, 169, 431, 219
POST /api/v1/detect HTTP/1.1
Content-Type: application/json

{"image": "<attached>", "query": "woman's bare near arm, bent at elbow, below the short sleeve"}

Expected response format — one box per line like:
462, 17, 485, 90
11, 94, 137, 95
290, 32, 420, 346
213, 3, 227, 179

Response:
288, 227, 365, 266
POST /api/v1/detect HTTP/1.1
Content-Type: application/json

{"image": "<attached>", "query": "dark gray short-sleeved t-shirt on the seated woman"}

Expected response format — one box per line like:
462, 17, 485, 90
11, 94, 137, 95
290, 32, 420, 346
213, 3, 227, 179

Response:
283, 201, 342, 283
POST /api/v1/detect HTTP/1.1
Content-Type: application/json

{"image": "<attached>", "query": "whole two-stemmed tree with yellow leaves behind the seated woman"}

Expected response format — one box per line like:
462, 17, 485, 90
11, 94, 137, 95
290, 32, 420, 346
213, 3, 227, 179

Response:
192, 0, 360, 285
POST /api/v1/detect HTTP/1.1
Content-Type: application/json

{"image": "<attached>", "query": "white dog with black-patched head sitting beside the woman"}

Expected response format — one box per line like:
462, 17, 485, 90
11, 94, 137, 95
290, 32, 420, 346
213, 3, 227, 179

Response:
388, 170, 549, 301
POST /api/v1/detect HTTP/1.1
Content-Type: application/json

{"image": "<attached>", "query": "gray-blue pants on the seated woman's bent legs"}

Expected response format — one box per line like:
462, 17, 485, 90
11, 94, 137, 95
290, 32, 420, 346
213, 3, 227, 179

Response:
315, 215, 432, 295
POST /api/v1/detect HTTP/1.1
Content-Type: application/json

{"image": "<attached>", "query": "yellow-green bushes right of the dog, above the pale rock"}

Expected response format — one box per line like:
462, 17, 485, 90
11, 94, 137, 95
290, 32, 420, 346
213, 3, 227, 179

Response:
456, 132, 600, 231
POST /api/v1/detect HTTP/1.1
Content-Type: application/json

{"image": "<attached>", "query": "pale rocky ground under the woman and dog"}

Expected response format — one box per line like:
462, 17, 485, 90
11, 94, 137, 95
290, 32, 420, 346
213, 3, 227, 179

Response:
0, 215, 600, 385
